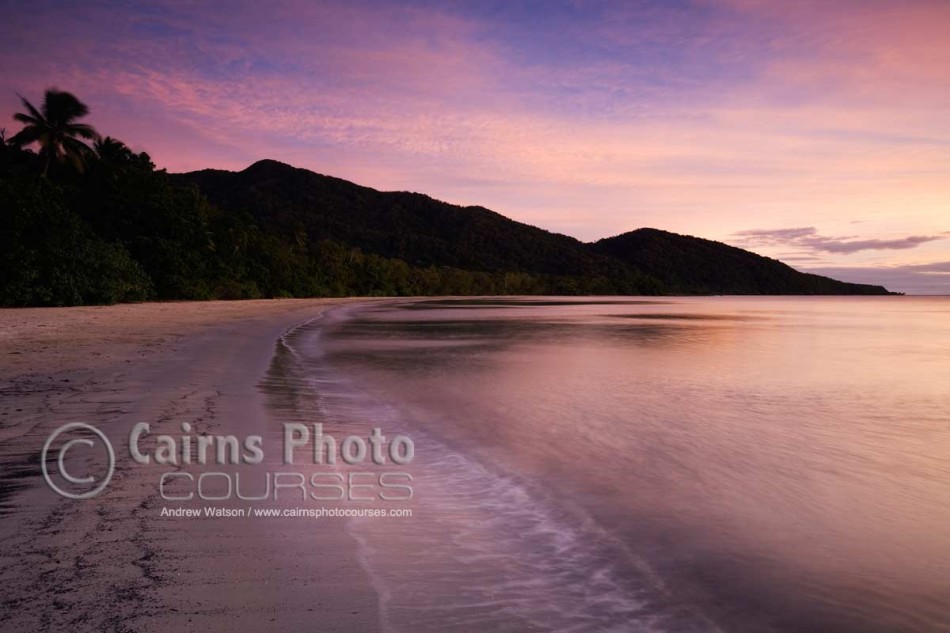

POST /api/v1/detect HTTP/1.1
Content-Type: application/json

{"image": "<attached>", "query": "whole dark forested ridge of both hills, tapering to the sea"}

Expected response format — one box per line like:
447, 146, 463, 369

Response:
174, 160, 888, 294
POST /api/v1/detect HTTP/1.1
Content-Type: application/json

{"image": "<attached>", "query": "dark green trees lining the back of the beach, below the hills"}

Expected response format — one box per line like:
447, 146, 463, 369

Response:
0, 141, 624, 306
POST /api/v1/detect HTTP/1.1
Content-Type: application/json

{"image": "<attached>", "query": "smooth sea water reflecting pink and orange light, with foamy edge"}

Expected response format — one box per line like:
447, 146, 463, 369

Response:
276, 297, 950, 631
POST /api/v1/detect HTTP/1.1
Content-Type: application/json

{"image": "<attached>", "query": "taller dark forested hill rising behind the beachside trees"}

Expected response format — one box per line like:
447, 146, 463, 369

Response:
174, 160, 624, 275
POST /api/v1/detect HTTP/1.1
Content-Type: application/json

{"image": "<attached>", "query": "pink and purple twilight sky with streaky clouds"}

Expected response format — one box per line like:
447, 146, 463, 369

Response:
0, 0, 950, 294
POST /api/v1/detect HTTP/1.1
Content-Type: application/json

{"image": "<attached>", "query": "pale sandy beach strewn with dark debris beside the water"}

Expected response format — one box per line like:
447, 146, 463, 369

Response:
0, 300, 379, 632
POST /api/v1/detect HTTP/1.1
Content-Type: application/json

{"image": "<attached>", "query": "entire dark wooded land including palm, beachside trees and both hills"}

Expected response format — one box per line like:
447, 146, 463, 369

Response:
0, 90, 886, 306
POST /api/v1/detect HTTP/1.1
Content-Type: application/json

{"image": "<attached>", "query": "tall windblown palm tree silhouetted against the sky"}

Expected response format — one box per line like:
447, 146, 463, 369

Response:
10, 88, 99, 176
